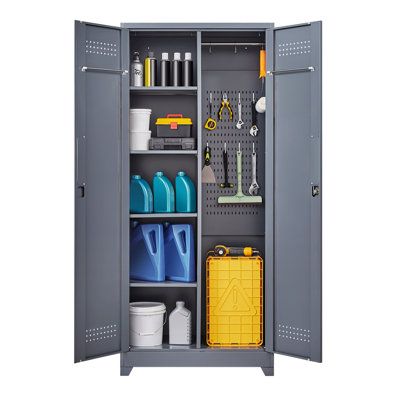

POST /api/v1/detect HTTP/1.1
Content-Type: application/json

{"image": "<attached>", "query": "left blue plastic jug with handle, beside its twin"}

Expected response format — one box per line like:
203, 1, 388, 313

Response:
130, 224, 165, 282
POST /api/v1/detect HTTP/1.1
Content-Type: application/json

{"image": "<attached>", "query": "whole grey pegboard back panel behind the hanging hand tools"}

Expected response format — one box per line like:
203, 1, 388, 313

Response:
202, 71, 265, 235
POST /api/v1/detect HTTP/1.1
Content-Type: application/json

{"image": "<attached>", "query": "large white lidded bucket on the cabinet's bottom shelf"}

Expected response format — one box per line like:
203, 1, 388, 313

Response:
129, 301, 167, 347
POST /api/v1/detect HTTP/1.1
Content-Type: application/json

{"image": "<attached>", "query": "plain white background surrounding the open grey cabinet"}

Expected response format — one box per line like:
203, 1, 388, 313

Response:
0, 0, 400, 400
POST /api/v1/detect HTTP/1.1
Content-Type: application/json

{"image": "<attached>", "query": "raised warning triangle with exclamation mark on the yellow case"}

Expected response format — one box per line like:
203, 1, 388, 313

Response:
214, 279, 256, 315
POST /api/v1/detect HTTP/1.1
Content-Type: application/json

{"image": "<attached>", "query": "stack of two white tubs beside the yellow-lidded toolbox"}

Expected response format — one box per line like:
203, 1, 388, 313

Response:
129, 108, 151, 150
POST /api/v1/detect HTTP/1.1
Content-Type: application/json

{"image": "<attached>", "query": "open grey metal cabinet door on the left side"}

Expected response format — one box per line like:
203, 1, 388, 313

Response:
75, 21, 129, 362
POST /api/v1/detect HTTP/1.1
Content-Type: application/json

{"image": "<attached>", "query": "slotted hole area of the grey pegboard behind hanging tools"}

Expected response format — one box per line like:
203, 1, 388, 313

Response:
203, 90, 264, 216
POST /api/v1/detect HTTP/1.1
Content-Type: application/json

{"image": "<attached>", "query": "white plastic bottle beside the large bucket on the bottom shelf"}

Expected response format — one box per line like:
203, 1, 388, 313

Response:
169, 301, 192, 344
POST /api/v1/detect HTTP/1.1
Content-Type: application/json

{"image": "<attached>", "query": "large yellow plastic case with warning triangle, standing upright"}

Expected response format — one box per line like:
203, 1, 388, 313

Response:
206, 256, 263, 347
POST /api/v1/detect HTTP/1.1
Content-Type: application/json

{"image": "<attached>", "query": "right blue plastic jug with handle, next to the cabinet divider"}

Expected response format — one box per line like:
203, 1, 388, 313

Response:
164, 224, 196, 282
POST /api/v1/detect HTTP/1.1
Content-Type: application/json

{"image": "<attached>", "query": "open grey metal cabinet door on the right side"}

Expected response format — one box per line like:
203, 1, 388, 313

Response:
266, 22, 322, 362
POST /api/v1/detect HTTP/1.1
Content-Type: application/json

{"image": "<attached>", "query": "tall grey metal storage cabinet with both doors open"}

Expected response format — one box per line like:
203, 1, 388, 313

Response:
75, 21, 322, 375
